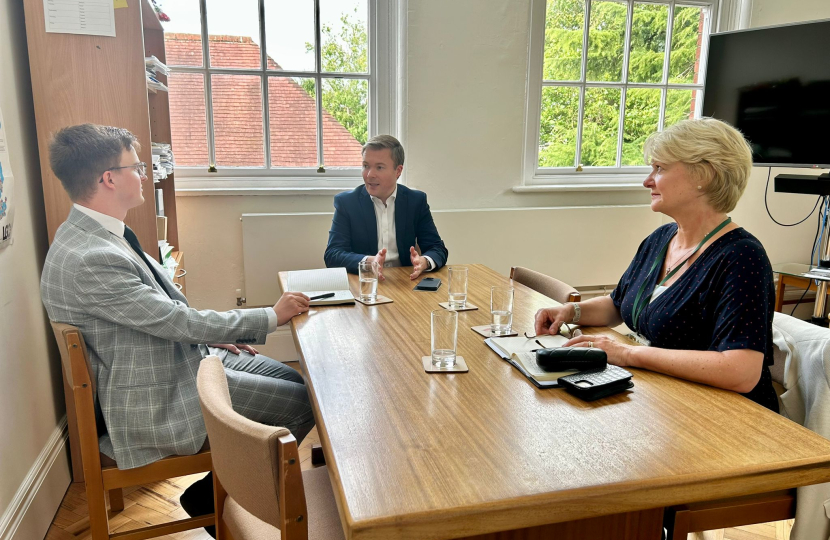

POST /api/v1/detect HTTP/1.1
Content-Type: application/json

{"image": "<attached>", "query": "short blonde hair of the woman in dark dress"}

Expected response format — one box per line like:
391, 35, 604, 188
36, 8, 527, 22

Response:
643, 118, 752, 213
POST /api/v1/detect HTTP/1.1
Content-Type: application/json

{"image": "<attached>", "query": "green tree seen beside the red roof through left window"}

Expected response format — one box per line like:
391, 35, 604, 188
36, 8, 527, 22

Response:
298, 8, 369, 144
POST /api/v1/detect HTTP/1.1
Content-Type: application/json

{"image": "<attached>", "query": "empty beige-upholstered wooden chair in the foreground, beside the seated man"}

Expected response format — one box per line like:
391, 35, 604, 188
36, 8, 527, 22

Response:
196, 356, 344, 540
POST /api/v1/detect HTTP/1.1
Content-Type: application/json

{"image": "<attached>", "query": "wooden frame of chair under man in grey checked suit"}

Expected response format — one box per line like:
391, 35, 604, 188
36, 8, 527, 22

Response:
52, 322, 216, 540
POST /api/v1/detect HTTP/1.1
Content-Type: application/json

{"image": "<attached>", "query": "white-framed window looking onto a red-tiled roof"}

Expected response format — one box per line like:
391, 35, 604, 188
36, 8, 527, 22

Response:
164, 0, 395, 184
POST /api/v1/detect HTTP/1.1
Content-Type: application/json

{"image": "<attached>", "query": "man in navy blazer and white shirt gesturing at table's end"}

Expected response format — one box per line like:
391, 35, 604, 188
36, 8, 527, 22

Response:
324, 135, 449, 279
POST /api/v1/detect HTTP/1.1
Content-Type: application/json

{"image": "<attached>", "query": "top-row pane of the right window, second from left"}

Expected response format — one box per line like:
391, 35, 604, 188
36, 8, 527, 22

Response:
587, 0, 628, 81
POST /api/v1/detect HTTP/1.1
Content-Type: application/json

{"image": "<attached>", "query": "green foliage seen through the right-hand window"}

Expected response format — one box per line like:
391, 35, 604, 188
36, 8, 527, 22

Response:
539, 0, 701, 167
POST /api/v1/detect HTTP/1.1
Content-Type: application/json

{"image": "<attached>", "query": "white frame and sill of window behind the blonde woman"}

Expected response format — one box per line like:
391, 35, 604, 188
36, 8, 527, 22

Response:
513, 0, 720, 192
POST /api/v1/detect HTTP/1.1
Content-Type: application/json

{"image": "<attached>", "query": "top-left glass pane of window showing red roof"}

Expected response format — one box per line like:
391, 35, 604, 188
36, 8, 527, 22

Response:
162, 0, 202, 67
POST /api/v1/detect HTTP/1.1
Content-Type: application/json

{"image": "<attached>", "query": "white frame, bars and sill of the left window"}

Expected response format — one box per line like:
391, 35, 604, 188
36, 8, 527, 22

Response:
170, 0, 407, 195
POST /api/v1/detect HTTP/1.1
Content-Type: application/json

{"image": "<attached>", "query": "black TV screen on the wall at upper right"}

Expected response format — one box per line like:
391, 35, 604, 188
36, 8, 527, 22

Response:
703, 20, 830, 167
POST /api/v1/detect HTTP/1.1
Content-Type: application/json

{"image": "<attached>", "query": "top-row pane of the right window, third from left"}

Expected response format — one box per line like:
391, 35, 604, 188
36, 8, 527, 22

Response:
628, 4, 669, 83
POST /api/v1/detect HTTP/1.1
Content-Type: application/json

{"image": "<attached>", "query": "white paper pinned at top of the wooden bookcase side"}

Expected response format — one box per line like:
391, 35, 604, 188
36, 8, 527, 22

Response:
43, 0, 115, 37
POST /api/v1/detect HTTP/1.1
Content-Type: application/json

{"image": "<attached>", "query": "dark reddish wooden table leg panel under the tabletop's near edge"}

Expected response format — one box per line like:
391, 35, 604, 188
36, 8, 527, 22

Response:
464, 508, 663, 540
